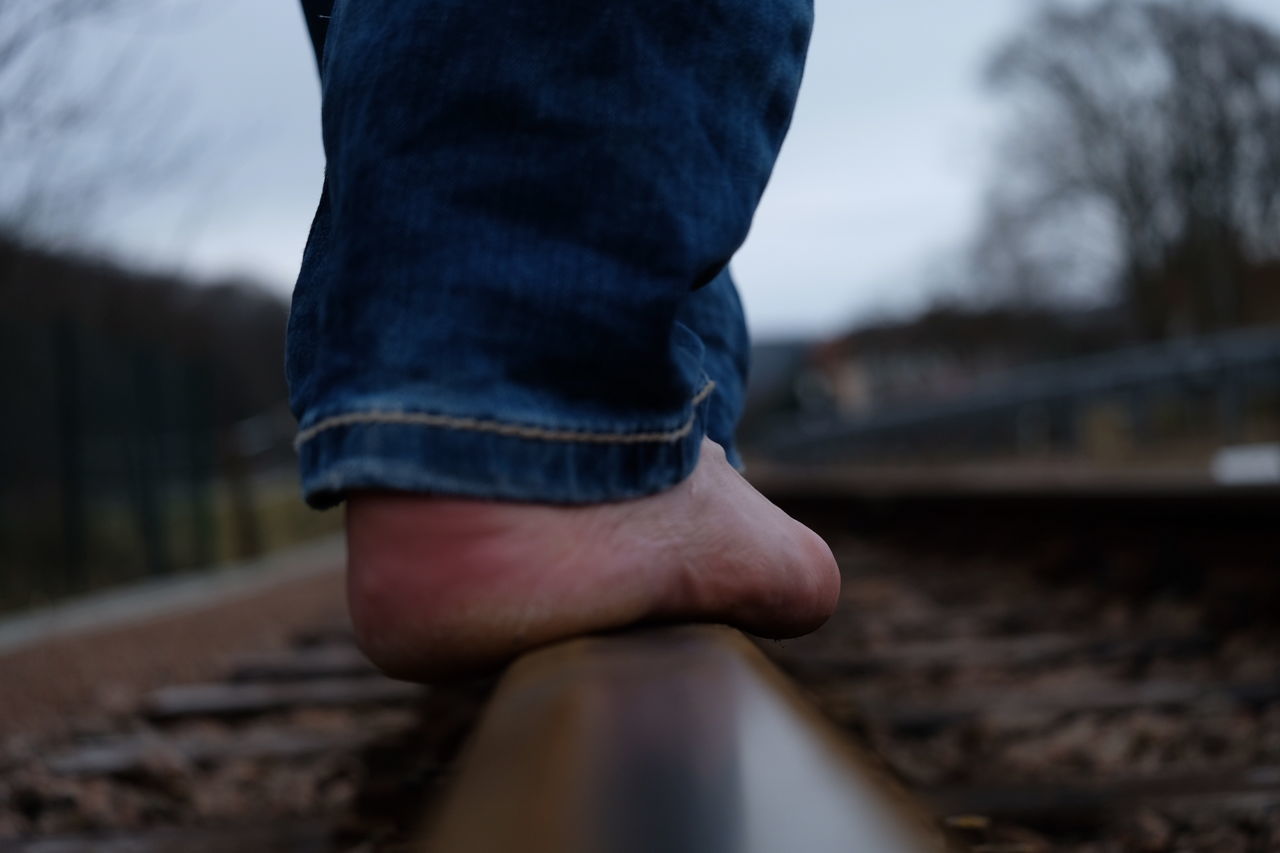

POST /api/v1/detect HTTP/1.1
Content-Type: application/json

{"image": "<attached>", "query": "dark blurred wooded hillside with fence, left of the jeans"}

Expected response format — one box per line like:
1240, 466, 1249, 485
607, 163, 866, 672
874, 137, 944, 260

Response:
0, 237, 324, 608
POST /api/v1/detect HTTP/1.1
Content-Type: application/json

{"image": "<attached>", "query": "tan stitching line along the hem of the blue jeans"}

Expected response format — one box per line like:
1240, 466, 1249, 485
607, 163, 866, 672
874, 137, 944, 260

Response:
293, 380, 716, 450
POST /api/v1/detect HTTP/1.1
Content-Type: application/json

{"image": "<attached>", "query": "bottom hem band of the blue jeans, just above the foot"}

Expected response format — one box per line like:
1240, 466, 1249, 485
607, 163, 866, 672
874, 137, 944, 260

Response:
296, 382, 716, 508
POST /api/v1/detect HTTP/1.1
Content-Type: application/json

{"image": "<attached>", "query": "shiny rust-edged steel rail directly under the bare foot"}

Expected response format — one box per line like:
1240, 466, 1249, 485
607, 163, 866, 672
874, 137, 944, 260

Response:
410, 626, 945, 853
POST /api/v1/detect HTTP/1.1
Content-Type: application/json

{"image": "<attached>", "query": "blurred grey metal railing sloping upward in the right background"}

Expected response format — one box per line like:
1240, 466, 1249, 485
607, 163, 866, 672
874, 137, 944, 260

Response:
758, 322, 1280, 464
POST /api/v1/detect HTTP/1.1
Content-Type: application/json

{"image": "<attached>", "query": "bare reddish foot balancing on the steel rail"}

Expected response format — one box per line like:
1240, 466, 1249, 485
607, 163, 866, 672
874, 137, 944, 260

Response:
347, 441, 840, 680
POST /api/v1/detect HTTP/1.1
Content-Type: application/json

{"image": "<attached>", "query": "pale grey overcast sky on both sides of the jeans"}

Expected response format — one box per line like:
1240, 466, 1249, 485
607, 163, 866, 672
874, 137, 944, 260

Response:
77, 0, 1280, 337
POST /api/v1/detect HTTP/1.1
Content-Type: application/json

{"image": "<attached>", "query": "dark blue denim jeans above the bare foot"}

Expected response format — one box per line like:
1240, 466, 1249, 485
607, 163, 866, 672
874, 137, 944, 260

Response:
287, 0, 813, 507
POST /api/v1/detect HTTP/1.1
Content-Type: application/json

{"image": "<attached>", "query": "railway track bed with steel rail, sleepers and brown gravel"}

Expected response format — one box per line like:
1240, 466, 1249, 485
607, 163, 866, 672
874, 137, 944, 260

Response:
0, 480, 1280, 853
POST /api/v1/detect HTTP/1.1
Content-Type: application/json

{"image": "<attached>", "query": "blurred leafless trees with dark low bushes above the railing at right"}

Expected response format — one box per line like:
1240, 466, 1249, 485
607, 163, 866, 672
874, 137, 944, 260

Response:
854, 0, 1280, 361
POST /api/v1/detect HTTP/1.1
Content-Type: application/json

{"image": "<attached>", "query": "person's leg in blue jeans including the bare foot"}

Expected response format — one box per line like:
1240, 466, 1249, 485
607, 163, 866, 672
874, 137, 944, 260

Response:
289, 0, 836, 678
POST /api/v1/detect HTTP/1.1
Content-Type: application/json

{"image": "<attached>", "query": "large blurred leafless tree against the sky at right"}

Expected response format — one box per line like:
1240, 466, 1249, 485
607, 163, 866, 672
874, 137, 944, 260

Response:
975, 0, 1280, 337
